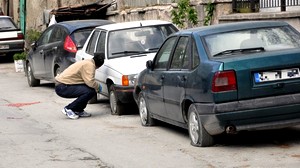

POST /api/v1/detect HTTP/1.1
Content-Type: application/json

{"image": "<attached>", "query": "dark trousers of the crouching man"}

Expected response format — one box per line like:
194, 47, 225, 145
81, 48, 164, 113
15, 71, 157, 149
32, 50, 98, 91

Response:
55, 84, 97, 112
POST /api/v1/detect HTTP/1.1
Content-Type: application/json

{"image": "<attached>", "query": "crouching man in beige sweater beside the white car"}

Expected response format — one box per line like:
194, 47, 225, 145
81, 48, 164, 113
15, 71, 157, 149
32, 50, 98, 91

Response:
55, 53, 104, 119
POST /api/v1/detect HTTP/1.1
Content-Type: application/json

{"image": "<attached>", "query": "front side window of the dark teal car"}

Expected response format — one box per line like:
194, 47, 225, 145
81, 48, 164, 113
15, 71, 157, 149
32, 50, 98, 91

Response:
153, 37, 176, 70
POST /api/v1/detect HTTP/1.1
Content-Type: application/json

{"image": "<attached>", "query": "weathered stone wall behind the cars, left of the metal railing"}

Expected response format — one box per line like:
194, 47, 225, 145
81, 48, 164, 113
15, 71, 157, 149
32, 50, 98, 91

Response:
0, 0, 231, 31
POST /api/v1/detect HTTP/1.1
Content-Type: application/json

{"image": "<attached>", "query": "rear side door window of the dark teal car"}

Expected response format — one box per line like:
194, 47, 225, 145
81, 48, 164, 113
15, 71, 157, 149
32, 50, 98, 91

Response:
170, 37, 189, 70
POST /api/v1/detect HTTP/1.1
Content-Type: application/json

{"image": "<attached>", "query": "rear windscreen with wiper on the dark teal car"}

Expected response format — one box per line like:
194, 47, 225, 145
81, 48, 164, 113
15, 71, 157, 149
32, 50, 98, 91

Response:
204, 26, 300, 57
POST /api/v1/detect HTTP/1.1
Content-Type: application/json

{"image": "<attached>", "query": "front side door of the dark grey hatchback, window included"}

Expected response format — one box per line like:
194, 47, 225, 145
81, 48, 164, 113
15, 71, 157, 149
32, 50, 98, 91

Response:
32, 26, 54, 78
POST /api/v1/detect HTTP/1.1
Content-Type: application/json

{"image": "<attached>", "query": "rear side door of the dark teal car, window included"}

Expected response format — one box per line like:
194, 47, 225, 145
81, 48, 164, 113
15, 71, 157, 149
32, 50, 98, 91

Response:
163, 36, 190, 122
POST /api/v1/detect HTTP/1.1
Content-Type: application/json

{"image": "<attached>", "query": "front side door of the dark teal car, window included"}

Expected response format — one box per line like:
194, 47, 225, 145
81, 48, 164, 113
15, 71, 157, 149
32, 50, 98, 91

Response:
145, 36, 177, 117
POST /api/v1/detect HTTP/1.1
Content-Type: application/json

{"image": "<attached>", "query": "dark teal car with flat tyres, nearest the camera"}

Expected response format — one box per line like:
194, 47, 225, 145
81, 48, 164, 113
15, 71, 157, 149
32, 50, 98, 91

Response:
134, 21, 300, 146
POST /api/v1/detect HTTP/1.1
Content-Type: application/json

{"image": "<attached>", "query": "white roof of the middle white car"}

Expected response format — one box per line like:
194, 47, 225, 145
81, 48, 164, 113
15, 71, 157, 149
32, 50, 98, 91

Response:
97, 20, 172, 31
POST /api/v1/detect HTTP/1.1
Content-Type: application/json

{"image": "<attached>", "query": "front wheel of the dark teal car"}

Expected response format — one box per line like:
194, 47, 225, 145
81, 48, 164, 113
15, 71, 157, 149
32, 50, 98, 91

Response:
138, 92, 154, 126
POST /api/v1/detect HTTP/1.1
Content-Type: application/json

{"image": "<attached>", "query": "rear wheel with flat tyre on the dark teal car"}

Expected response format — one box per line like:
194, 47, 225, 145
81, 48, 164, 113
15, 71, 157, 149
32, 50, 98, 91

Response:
188, 104, 214, 147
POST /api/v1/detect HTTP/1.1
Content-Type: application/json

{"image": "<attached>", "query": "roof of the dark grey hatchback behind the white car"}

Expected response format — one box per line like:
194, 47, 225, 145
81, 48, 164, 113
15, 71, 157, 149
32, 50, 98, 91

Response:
57, 19, 114, 33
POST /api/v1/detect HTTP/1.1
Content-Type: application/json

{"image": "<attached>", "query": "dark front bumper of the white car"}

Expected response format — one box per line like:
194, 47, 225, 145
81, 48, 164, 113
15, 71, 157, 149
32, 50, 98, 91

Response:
114, 85, 134, 103
